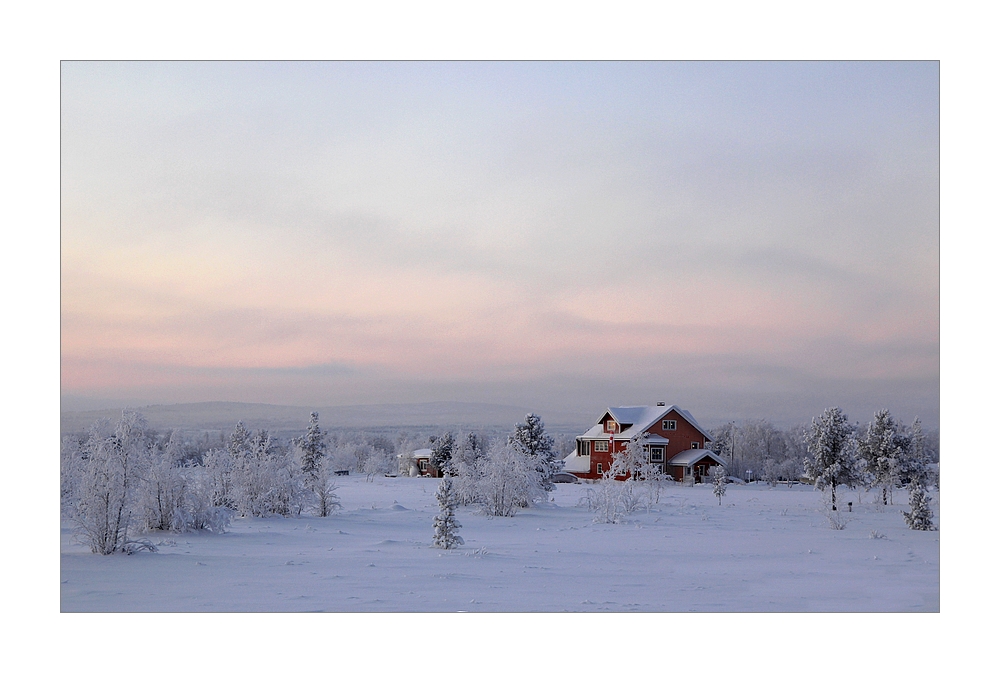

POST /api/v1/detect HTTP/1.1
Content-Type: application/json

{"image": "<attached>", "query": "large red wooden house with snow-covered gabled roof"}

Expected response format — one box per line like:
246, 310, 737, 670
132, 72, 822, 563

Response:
565, 403, 726, 482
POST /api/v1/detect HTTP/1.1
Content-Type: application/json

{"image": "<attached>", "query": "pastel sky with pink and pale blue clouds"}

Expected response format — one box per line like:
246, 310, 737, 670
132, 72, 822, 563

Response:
61, 62, 940, 426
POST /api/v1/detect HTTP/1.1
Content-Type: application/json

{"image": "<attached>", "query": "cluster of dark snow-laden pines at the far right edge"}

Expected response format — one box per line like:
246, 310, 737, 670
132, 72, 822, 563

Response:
805, 408, 936, 530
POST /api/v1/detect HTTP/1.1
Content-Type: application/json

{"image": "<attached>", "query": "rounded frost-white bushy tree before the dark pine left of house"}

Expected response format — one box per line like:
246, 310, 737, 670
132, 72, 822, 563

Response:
477, 439, 545, 517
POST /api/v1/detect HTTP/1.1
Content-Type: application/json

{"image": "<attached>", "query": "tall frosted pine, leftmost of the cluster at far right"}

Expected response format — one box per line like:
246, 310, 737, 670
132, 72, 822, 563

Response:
805, 408, 856, 511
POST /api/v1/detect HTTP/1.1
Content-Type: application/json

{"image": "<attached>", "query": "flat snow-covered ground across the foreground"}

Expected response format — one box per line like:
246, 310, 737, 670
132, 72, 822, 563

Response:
60, 476, 940, 612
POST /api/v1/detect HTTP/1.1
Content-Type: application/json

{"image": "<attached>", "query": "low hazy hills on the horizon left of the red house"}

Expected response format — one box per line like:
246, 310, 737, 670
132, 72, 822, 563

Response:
61, 401, 593, 433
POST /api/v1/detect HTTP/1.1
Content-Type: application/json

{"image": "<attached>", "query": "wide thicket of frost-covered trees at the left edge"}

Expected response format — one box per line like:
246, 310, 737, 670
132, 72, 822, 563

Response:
61, 410, 352, 555
